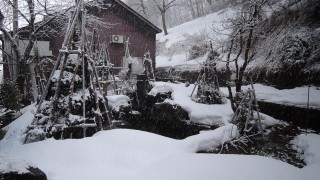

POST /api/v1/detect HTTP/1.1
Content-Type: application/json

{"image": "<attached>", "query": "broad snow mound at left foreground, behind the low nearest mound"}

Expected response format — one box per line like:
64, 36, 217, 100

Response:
0, 112, 237, 180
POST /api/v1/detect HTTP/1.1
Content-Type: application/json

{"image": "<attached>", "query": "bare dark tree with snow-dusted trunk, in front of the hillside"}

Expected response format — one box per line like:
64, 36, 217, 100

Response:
227, 0, 268, 110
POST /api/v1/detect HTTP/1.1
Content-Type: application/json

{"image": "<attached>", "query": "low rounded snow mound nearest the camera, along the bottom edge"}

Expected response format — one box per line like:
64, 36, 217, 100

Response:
134, 154, 302, 180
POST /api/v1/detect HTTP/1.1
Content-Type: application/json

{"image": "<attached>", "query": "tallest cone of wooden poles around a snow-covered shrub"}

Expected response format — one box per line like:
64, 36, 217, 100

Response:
25, 0, 113, 142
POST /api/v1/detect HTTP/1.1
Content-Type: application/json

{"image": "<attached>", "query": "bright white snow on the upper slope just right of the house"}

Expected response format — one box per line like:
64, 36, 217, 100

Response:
156, 8, 235, 69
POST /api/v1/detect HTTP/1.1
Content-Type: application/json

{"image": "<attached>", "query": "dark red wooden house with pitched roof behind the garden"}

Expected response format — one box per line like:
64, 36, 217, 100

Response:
2, 0, 161, 78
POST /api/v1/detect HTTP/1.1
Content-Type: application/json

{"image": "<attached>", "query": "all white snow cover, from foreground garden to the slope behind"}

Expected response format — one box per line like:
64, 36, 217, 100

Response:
0, 2, 320, 180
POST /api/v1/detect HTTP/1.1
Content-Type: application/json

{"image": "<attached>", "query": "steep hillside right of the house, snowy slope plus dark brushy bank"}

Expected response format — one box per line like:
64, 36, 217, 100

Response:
156, 1, 320, 88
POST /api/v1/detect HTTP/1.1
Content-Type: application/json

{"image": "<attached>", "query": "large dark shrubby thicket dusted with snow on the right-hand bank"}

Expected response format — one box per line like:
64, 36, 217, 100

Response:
247, 1, 320, 88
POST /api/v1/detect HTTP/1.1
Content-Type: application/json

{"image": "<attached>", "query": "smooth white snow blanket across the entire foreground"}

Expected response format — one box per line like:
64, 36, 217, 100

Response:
0, 102, 320, 180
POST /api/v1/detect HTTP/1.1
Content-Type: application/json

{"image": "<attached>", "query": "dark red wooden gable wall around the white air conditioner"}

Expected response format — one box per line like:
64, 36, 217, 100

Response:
53, 3, 158, 71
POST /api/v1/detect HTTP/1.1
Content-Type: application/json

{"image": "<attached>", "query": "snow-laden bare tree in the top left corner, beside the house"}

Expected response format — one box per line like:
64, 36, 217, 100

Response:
0, 0, 107, 105
